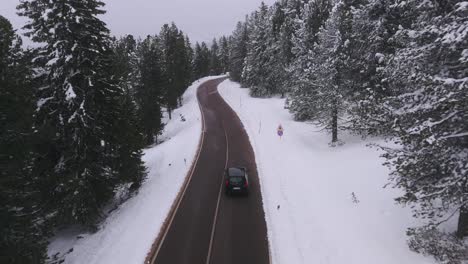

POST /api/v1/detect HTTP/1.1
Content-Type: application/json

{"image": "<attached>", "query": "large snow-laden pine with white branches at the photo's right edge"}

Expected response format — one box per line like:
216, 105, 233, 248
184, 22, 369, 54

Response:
385, 1, 468, 248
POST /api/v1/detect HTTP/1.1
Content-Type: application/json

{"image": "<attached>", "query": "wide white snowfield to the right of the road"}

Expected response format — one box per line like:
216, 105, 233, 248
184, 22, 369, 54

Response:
219, 81, 435, 264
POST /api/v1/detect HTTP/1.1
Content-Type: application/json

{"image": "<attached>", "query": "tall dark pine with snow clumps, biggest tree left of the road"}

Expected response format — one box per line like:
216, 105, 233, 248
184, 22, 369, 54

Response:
19, 0, 131, 226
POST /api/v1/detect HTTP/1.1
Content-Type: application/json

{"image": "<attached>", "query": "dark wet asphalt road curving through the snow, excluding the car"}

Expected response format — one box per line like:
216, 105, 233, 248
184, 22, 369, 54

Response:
150, 78, 270, 264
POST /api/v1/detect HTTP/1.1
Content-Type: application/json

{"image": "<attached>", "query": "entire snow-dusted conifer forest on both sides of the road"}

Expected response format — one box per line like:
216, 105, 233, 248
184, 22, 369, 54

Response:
0, 0, 468, 264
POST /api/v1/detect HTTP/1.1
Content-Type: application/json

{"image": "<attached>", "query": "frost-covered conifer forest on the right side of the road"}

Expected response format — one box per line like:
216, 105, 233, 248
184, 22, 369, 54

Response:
223, 0, 468, 263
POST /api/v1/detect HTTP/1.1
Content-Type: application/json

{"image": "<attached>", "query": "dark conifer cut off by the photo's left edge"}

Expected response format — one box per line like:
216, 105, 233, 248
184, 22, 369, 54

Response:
0, 16, 46, 264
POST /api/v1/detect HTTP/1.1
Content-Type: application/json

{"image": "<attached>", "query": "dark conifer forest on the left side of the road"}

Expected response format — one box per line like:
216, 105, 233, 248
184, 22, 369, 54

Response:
0, 0, 227, 264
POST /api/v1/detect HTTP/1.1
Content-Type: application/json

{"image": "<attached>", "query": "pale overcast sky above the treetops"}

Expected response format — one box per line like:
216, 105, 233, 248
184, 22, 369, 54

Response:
0, 0, 275, 46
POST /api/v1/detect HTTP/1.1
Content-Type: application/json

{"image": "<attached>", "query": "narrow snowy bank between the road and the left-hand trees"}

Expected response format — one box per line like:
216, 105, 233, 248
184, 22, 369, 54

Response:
48, 77, 222, 264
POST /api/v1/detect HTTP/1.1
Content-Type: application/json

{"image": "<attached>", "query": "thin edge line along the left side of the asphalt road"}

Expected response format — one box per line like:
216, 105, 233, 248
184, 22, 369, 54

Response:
144, 79, 207, 264
